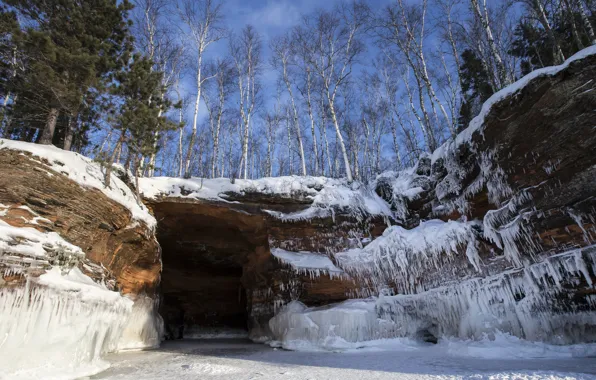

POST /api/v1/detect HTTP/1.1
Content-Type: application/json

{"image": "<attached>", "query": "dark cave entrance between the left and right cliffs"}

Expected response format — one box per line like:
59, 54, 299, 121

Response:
152, 202, 266, 339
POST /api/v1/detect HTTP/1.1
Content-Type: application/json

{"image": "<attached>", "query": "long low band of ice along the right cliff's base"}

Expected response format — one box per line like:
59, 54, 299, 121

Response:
269, 246, 596, 349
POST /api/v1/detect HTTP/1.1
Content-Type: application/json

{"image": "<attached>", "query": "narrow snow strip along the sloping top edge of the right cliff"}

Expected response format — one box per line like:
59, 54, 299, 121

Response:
432, 45, 596, 162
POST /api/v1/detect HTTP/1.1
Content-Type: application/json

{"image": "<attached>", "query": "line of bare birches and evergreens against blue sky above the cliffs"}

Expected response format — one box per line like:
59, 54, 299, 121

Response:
0, 0, 596, 183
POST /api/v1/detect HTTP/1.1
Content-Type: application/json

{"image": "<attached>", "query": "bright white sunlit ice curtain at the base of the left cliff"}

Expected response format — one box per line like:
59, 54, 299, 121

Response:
0, 267, 132, 378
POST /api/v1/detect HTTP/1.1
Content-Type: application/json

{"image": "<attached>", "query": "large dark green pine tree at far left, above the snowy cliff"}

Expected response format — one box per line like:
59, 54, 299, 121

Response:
6, 0, 132, 144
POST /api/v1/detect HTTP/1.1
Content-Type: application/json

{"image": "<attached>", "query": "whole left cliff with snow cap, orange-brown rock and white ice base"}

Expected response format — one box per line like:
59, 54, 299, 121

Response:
0, 140, 163, 379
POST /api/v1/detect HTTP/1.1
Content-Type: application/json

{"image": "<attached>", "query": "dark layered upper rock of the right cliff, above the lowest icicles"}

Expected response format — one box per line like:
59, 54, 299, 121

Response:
376, 49, 596, 291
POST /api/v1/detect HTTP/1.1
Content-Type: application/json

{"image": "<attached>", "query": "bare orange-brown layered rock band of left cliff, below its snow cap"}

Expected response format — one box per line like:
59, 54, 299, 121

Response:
0, 149, 161, 297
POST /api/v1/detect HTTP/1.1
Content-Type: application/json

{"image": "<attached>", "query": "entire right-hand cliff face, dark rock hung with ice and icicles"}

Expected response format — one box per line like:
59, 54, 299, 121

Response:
269, 47, 596, 348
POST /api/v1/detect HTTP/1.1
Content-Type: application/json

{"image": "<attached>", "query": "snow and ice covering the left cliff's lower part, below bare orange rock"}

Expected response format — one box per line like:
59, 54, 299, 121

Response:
0, 220, 161, 379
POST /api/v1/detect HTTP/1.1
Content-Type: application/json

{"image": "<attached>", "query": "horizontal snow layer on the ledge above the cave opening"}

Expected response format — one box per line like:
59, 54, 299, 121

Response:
139, 176, 392, 220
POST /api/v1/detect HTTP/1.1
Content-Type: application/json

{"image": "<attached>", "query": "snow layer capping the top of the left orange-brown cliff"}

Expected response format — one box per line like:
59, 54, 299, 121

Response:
0, 139, 157, 228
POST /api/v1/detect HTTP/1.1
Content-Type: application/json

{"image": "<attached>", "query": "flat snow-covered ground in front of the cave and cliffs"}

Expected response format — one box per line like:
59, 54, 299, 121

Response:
91, 340, 596, 380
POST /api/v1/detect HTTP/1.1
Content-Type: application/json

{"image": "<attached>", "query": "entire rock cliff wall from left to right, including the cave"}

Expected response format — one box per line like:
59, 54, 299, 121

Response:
0, 47, 596, 377
